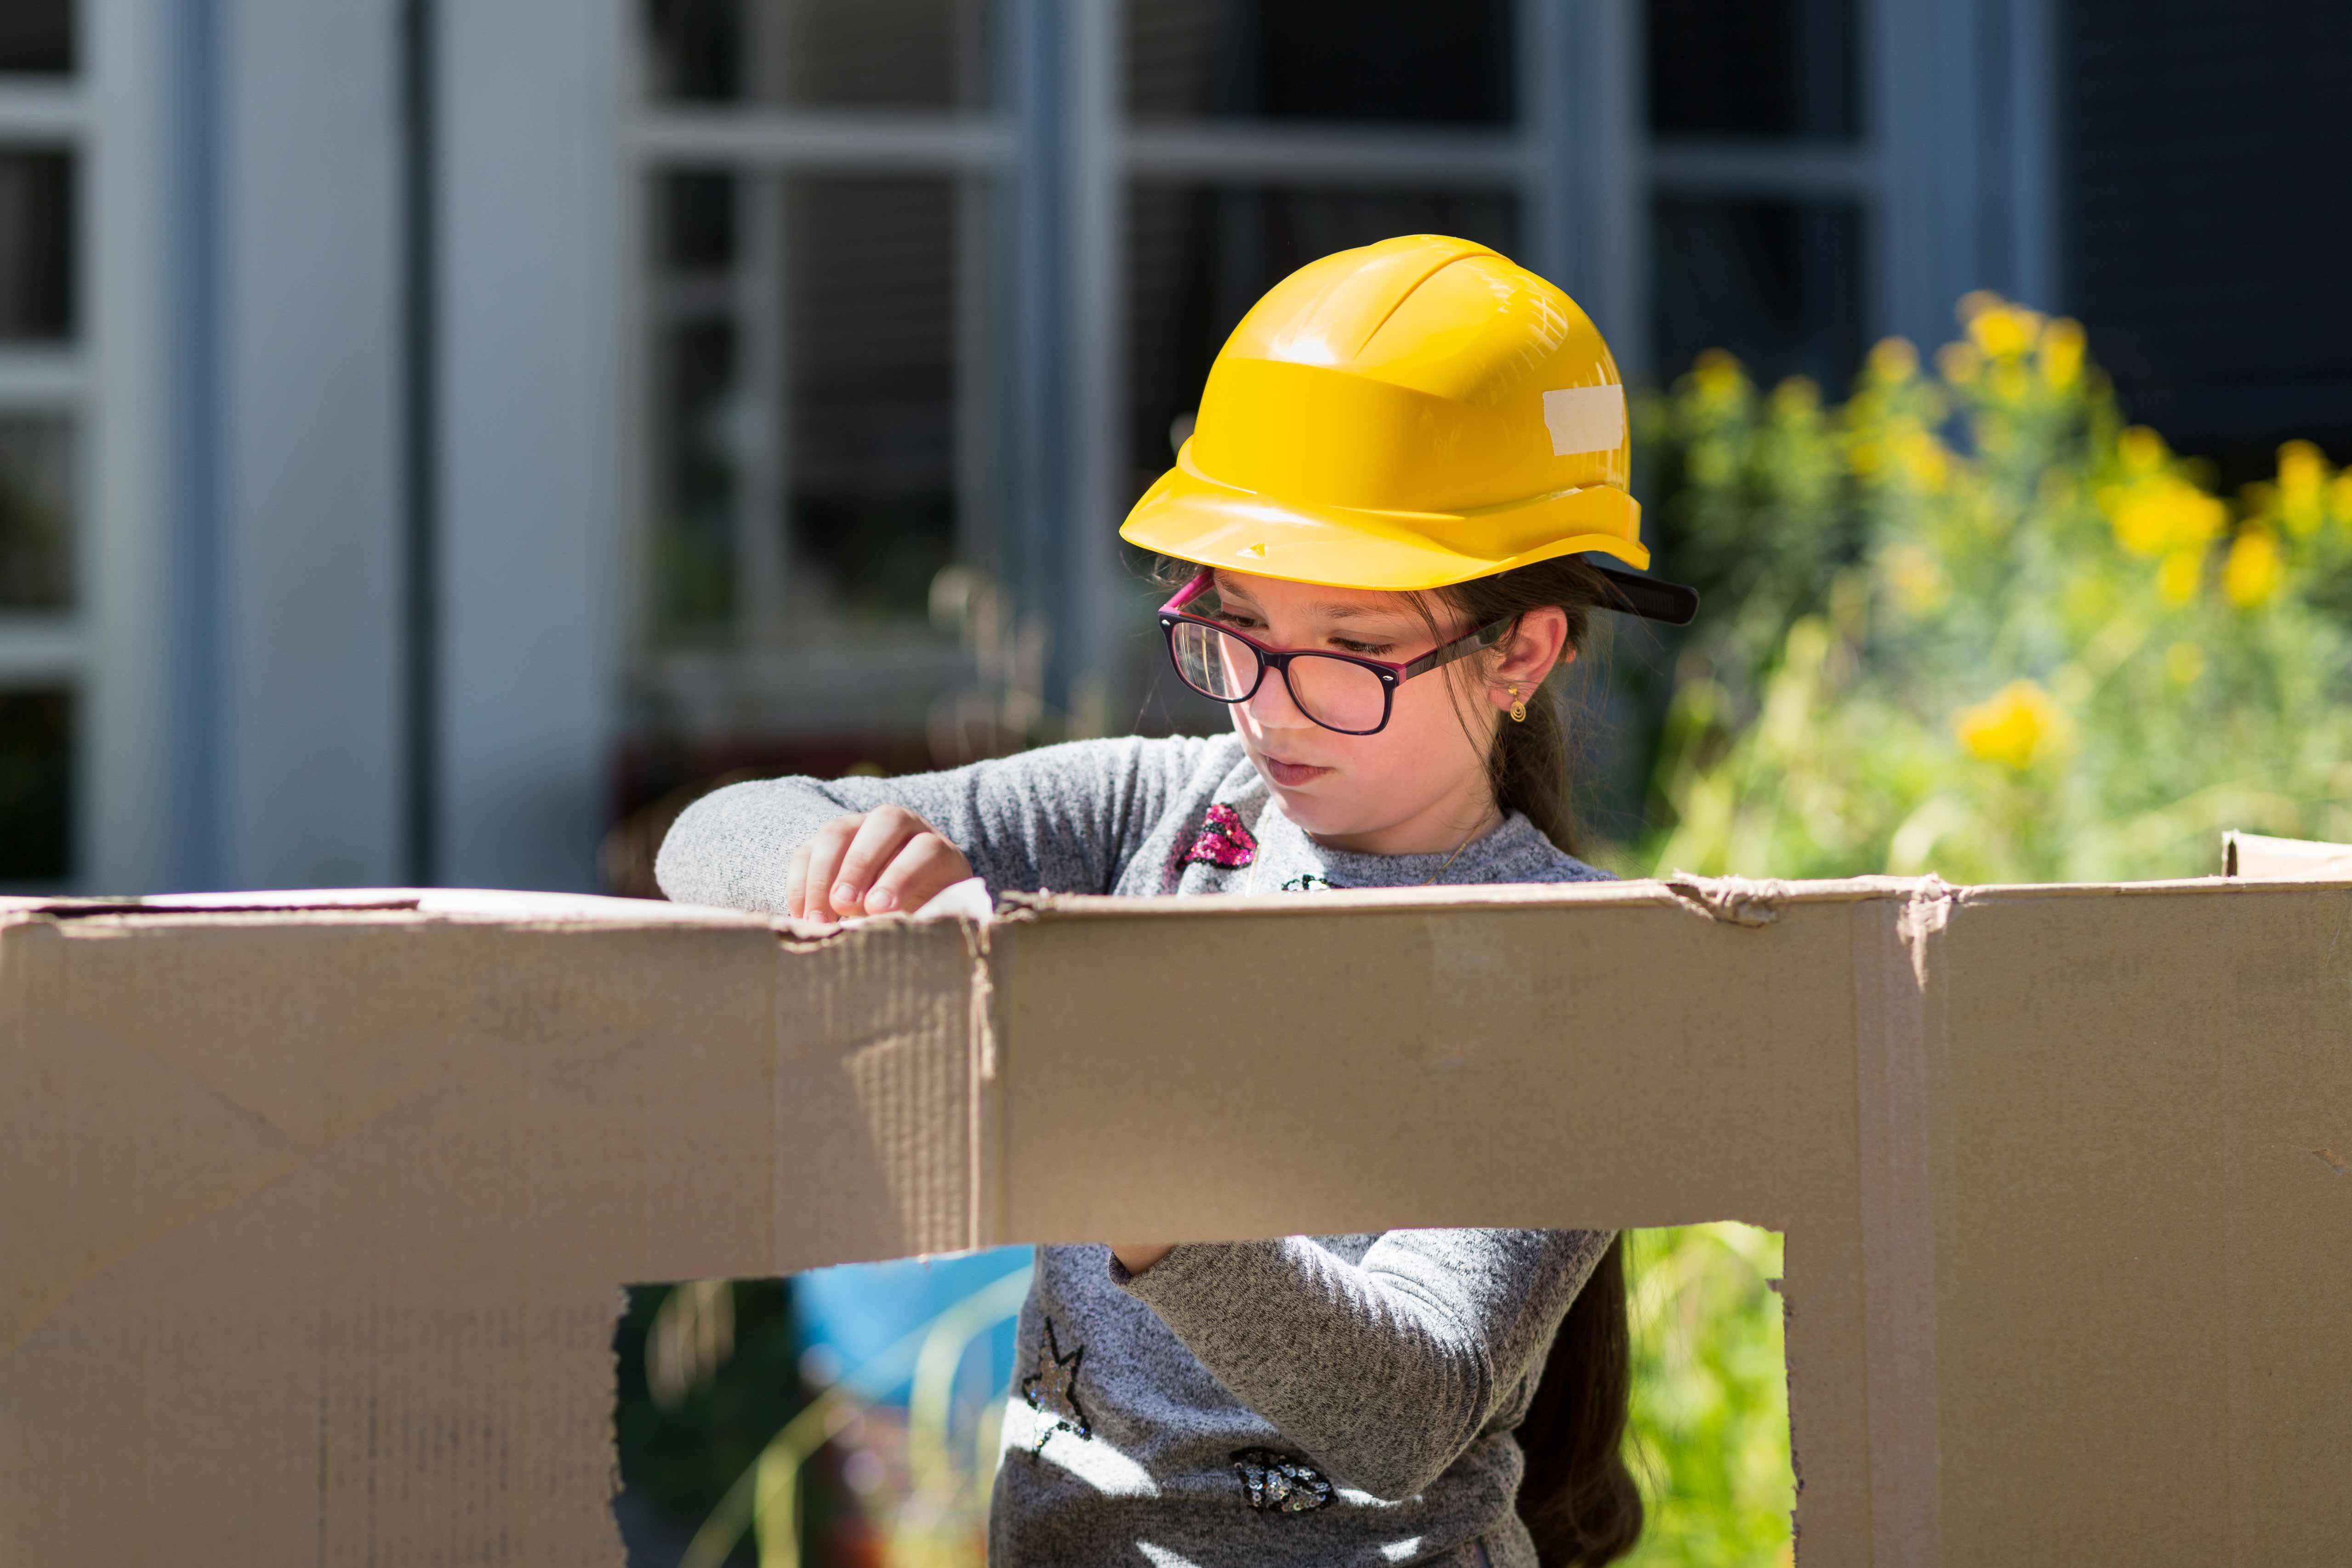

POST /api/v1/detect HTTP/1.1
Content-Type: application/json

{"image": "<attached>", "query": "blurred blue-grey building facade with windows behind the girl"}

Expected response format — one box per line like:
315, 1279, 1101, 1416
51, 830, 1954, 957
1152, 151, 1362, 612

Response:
0, 0, 2314, 891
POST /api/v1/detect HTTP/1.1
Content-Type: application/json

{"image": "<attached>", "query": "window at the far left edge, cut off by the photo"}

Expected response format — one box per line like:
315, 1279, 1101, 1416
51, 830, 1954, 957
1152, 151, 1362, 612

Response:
0, 0, 92, 889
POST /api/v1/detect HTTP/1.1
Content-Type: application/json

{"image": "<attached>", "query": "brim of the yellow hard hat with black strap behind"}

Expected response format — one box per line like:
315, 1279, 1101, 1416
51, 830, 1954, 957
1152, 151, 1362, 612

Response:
1120, 446, 1698, 625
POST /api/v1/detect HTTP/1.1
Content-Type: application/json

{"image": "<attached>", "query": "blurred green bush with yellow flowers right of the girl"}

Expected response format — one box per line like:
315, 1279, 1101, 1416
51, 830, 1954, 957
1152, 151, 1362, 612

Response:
1634, 296, 2352, 882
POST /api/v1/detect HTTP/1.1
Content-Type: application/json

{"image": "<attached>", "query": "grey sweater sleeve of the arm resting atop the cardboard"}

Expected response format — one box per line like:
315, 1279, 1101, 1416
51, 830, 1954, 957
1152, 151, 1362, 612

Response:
654, 738, 1213, 912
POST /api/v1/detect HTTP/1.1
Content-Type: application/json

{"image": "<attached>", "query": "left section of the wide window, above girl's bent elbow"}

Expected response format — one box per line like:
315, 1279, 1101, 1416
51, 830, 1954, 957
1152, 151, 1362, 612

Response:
628, 0, 1004, 797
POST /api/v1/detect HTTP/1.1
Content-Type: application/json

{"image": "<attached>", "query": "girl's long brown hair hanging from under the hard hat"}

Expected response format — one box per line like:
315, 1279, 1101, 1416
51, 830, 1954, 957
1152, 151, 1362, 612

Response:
1435, 557, 1642, 1568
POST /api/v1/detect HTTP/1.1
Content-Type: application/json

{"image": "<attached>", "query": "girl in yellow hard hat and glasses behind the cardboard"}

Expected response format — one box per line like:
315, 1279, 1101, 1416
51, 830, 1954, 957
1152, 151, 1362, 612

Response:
659, 235, 1696, 1568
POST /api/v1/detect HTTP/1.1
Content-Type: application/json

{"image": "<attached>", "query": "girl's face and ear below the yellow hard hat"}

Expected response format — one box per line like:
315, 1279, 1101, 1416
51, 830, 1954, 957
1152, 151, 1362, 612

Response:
1195, 569, 1573, 853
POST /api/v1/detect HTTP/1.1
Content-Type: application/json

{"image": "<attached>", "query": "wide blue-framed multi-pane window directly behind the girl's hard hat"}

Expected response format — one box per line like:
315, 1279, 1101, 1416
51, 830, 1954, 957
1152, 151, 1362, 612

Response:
623, 0, 1884, 802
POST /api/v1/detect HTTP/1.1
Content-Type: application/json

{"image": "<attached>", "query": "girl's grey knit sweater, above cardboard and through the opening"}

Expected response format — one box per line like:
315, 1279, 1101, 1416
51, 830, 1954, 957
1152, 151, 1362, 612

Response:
656, 736, 1611, 1568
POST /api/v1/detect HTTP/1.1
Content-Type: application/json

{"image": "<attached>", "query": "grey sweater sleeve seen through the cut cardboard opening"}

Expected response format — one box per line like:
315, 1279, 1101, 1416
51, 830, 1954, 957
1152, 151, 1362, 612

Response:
1110, 1230, 1616, 1498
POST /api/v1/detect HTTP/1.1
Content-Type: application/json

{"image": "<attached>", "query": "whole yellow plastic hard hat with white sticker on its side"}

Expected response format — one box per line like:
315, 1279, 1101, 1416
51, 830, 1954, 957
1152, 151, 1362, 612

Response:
1120, 235, 1698, 623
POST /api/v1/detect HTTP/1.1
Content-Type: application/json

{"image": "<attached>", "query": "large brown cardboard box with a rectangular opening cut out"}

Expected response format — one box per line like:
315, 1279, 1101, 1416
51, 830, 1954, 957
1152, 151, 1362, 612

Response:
0, 879, 2352, 1568
